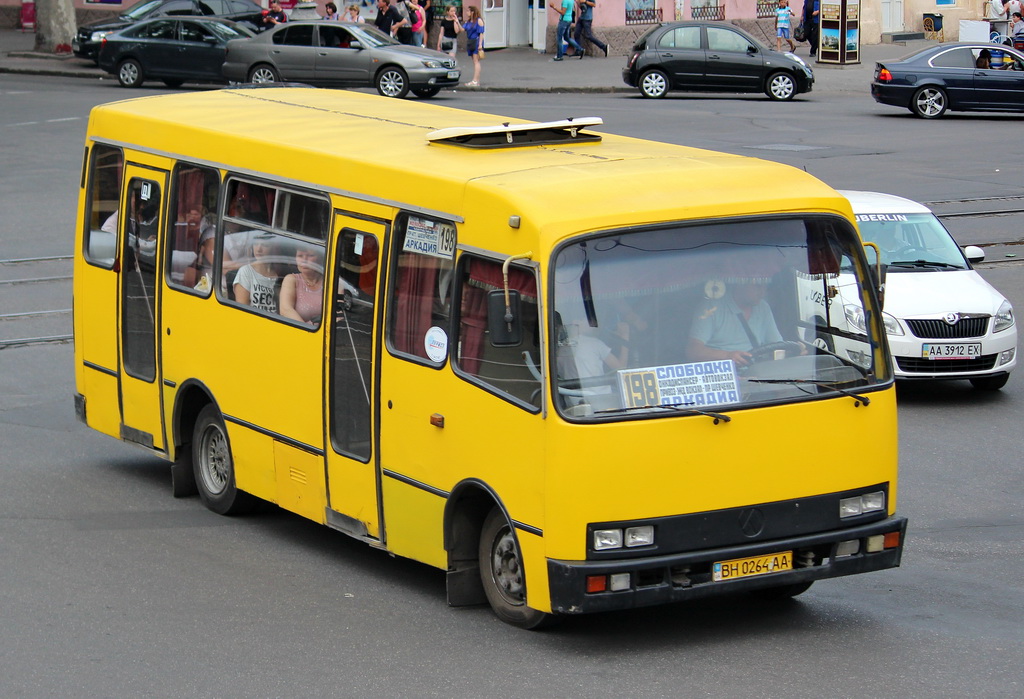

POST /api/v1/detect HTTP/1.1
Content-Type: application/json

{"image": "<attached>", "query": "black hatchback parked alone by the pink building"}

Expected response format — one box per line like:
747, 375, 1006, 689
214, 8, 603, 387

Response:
623, 21, 814, 99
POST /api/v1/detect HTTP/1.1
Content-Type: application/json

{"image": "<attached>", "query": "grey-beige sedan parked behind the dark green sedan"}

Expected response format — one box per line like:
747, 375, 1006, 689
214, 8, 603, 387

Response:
228, 21, 460, 97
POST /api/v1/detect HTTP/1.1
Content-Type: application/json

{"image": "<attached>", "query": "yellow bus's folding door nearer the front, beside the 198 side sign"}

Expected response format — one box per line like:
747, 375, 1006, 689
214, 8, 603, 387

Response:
327, 219, 386, 541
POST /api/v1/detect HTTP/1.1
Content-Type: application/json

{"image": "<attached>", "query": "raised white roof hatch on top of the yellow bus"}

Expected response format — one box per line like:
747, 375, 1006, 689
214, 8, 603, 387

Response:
427, 117, 604, 148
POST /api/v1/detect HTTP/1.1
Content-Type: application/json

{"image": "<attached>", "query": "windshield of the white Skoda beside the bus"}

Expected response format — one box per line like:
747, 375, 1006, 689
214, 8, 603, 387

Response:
857, 213, 968, 271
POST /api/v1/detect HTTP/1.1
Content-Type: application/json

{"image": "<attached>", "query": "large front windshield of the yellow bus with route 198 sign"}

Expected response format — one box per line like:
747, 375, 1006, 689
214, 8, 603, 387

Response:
552, 216, 889, 419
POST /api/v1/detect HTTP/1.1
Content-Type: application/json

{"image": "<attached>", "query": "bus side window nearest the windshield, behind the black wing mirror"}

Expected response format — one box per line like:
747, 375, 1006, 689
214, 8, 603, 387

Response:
456, 255, 542, 408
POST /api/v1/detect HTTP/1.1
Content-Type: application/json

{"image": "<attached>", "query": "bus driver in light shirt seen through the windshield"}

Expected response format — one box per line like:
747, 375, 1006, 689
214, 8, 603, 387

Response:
687, 279, 782, 366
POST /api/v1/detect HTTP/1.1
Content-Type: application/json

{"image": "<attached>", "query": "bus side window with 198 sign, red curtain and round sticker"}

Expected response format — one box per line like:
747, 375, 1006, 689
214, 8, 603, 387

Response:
388, 215, 456, 365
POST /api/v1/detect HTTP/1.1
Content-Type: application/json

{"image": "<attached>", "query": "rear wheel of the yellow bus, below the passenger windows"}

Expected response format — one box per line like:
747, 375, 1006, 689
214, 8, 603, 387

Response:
193, 403, 254, 515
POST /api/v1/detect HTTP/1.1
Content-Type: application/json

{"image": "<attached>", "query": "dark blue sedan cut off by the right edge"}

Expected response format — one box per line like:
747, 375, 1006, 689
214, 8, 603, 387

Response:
871, 42, 1024, 119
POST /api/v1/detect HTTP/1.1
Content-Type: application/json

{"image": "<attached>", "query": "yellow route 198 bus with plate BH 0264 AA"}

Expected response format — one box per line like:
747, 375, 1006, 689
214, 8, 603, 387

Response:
74, 87, 906, 627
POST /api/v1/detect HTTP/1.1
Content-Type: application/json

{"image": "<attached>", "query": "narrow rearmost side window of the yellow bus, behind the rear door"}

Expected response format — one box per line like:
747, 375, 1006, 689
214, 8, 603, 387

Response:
84, 143, 124, 267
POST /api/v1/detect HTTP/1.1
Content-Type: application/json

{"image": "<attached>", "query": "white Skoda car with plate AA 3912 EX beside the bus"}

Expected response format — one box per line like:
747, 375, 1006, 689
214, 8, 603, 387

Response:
841, 191, 1017, 391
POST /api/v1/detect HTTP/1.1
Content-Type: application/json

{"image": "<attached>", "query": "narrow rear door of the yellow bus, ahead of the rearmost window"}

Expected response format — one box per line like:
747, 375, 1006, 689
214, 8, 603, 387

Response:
118, 171, 167, 450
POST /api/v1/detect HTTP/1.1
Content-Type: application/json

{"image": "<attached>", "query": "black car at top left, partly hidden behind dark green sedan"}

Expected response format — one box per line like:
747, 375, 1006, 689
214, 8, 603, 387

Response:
72, 0, 263, 60
